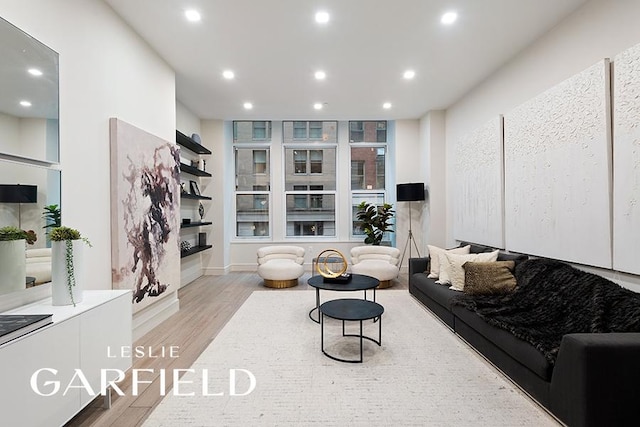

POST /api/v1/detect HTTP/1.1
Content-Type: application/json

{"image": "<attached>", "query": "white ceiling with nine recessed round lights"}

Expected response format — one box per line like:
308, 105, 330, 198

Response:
104, 0, 586, 120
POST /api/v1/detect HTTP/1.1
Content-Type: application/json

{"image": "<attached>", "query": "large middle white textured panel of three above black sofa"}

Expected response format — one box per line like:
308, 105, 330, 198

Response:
504, 60, 612, 268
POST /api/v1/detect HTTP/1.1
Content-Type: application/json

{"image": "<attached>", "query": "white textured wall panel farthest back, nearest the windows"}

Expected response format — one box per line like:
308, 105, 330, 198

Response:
453, 116, 504, 248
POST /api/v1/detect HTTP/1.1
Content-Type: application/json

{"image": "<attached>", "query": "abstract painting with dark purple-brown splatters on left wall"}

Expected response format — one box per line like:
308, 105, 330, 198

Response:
109, 119, 180, 311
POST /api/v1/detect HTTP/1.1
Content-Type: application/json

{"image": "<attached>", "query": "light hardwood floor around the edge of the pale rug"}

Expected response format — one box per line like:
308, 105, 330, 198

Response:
66, 273, 408, 427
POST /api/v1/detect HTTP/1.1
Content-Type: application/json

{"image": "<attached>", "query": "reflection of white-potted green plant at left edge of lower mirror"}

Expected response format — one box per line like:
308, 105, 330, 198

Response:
0, 226, 37, 293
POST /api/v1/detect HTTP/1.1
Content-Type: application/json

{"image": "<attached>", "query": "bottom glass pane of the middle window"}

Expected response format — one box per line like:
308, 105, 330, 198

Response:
286, 193, 336, 236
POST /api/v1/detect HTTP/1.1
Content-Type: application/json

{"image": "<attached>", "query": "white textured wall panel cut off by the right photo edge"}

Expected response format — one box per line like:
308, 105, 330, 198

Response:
613, 44, 640, 274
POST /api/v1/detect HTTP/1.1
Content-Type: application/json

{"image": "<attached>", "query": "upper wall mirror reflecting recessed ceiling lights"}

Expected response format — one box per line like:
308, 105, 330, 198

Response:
0, 18, 59, 163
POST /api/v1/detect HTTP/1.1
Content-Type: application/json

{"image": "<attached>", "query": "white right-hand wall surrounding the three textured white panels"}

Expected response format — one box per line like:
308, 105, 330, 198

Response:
446, 0, 640, 290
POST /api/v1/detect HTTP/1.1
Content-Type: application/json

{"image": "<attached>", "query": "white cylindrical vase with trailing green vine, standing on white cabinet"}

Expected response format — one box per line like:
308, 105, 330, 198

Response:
51, 240, 85, 305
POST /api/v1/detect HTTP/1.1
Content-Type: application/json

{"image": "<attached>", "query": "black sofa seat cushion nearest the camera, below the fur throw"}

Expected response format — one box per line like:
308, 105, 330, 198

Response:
452, 305, 553, 381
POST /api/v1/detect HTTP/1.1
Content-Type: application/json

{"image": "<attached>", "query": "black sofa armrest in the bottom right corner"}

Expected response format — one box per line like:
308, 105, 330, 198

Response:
551, 333, 640, 427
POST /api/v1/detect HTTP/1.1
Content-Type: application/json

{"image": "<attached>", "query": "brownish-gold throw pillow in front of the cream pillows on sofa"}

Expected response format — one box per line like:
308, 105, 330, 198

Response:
463, 261, 516, 295
